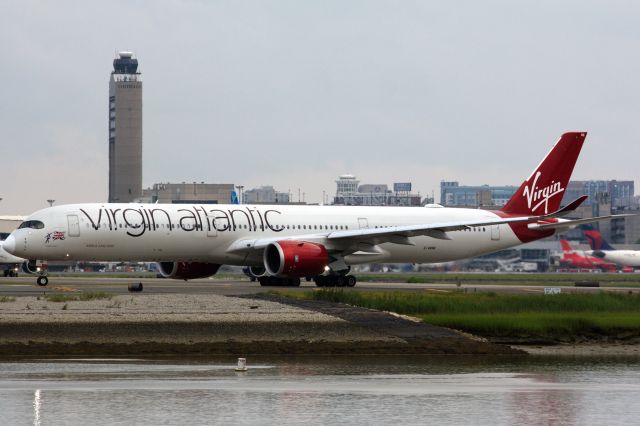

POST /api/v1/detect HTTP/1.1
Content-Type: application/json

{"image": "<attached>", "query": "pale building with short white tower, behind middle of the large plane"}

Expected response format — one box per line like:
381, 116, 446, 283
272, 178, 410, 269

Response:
333, 174, 422, 206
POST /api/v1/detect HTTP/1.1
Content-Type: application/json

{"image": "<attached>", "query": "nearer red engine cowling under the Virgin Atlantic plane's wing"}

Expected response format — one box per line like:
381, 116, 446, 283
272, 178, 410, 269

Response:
264, 240, 329, 277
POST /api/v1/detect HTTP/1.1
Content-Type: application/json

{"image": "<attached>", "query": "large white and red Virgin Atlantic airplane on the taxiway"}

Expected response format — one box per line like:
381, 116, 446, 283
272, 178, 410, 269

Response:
5, 132, 622, 287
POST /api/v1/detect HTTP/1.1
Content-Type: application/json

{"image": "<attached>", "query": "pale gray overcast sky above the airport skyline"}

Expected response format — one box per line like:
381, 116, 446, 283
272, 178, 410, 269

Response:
0, 0, 640, 214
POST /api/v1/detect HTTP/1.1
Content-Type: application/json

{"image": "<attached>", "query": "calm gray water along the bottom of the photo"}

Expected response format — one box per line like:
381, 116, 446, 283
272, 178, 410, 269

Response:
0, 356, 640, 425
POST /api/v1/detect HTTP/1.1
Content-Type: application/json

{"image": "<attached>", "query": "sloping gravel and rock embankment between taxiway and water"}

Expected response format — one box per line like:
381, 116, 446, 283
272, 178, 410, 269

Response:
0, 294, 522, 358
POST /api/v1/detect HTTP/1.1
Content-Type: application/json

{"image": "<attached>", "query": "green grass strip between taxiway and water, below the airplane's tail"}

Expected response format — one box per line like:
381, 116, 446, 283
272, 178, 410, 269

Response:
285, 289, 640, 341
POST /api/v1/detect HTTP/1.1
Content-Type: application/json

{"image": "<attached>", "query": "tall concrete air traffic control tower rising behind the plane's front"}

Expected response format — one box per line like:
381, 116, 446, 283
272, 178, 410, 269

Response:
109, 52, 142, 203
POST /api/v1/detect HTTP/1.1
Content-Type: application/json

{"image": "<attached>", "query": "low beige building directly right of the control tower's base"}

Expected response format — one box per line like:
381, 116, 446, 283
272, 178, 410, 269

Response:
142, 182, 234, 204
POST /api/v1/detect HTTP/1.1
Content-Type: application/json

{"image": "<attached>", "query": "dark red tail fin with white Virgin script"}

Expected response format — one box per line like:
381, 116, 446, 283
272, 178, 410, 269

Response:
501, 132, 587, 215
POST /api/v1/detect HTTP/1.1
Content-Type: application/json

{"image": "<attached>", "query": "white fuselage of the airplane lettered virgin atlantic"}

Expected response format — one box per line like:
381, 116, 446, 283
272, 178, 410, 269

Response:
7, 204, 521, 265
